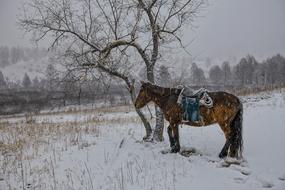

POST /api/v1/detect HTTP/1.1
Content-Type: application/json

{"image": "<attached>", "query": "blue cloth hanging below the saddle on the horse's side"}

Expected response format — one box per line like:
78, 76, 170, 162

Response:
181, 96, 200, 122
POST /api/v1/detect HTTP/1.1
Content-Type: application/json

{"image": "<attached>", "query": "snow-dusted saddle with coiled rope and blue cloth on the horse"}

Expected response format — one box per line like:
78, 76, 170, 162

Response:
177, 86, 213, 122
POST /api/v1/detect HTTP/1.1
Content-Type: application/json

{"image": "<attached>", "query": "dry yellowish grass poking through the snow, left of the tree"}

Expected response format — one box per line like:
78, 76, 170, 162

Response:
0, 106, 144, 189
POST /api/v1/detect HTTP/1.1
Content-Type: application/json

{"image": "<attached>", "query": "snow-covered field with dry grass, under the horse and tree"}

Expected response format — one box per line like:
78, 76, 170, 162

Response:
0, 90, 285, 190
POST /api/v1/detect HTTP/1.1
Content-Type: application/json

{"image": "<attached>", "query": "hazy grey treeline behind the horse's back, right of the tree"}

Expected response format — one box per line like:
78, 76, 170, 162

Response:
149, 54, 285, 95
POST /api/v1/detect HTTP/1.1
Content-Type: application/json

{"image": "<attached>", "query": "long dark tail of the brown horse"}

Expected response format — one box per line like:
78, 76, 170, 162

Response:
230, 101, 243, 158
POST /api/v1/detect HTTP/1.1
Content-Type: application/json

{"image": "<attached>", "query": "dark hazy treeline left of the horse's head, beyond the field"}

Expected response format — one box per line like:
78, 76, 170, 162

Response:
0, 64, 129, 115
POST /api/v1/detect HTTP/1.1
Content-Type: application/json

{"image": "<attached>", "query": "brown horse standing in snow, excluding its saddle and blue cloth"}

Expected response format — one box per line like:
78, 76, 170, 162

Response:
135, 82, 243, 158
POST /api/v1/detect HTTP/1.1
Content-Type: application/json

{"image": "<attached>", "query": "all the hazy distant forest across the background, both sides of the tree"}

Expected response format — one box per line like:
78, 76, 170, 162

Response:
0, 47, 285, 115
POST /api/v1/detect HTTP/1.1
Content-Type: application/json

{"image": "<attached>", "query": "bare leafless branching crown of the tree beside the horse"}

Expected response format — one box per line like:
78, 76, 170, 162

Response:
19, 0, 204, 140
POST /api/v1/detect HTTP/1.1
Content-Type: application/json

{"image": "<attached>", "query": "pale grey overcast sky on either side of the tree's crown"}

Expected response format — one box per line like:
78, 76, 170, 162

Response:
0, 0, 285, 59
